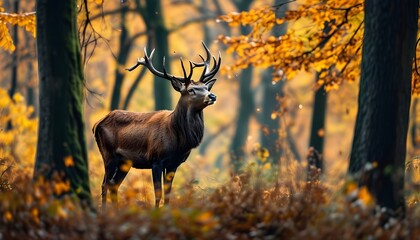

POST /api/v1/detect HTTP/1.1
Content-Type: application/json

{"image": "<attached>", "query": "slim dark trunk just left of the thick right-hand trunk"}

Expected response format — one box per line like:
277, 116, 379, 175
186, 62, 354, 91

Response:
308, 79, 327, 172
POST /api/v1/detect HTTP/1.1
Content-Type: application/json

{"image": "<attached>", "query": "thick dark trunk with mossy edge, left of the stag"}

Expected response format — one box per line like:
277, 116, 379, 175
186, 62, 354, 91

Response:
34, 0, 91, 203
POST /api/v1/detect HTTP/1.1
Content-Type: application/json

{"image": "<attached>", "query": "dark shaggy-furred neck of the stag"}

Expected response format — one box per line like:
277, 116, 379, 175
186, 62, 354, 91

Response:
172, 98, 204, 150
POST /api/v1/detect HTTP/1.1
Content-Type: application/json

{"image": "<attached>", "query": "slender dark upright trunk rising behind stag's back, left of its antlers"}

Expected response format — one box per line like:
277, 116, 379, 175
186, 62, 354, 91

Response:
110, 6, 131, 110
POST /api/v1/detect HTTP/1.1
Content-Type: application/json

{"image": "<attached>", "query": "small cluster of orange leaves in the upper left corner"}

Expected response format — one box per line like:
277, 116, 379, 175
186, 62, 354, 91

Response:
0, 0, 36, 52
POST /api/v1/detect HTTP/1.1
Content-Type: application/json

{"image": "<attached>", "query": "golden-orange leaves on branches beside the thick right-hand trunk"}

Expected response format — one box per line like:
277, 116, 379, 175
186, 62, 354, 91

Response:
219, 0, 420, 93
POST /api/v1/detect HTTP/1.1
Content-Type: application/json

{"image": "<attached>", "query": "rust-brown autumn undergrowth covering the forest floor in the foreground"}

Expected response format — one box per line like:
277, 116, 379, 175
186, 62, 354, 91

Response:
0, 162, 420, 239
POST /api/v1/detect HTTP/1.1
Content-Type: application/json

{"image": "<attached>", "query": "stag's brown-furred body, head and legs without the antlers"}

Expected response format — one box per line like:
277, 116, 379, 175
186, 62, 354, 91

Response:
92, 83, 215, 206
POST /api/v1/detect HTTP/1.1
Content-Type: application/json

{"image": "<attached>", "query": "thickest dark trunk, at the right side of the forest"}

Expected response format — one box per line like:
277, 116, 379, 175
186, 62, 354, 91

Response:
348, 0, 419, 210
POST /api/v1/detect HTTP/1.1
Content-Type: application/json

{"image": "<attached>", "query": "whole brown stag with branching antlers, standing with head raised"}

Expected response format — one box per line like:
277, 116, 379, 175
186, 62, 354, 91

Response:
92, 43, 221, 208
